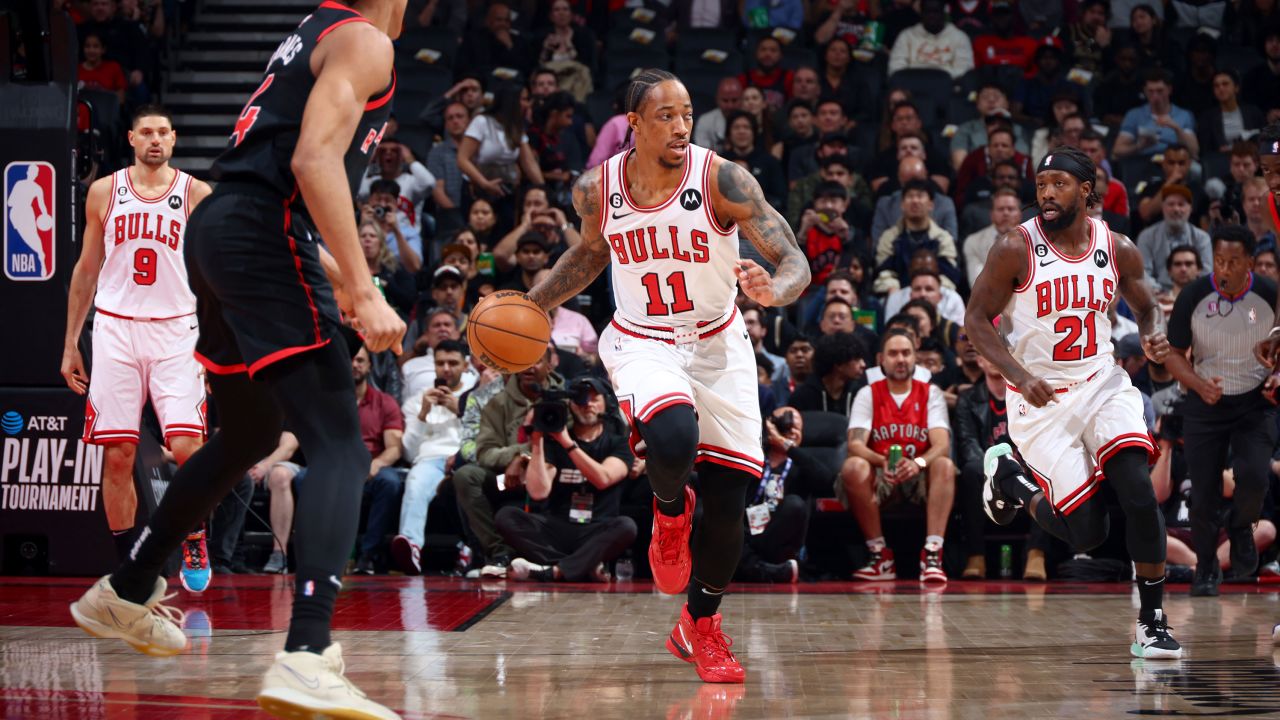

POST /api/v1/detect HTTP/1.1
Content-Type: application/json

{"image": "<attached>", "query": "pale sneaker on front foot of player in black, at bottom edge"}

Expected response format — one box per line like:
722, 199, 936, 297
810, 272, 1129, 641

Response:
257, 643, 401, 720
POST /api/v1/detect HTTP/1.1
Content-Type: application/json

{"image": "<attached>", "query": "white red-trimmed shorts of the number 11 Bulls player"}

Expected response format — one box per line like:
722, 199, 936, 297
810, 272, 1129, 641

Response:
599, 309, 764, 478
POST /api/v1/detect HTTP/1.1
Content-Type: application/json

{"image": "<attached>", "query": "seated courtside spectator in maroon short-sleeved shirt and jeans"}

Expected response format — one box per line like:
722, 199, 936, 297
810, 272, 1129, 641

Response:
351, 347, 404, 575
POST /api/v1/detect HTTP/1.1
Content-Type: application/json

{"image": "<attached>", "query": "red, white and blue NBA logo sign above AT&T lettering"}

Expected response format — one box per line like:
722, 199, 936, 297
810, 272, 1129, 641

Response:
4, 161, 56, 281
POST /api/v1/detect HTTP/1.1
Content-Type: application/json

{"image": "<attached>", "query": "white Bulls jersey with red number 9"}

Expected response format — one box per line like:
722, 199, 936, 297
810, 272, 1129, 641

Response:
93, 168, 196, 318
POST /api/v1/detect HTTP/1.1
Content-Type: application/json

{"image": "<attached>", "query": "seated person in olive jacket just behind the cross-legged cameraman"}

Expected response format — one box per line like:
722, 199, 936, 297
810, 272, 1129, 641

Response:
453, 343, 564, 578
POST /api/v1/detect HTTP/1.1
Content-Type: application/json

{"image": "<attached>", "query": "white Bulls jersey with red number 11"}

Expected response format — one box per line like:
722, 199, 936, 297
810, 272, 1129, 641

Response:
600, 145, 739, 325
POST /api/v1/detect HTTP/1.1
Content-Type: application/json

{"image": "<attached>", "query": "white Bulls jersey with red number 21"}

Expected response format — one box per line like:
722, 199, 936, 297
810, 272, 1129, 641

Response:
1002, 215, 1120, 387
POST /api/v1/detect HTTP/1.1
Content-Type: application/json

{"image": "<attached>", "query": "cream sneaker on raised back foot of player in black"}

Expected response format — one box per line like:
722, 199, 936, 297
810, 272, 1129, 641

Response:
72, 575, 189, 657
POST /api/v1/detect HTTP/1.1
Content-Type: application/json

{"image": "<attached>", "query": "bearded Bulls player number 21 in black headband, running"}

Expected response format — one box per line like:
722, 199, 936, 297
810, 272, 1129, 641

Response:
965, 147, 1183, 659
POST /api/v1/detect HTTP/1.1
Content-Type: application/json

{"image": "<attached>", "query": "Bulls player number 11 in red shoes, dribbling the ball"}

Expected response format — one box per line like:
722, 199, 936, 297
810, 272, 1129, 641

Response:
529, 69, 809, 683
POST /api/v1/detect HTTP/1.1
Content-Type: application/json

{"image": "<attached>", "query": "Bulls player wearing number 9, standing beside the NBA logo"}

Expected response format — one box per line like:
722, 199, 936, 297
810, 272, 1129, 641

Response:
61, 105, 212, 592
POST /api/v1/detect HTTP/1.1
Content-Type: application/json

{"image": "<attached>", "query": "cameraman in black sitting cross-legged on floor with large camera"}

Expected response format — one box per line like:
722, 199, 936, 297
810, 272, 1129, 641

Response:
497, 375, 636, 583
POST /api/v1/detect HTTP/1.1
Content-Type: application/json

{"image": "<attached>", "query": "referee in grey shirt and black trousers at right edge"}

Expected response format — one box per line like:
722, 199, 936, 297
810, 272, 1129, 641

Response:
1165, 225, 1276, 596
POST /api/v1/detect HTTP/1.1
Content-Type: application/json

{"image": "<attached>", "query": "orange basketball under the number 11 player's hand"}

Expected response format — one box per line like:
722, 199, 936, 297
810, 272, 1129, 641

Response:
467, 290, 552, 373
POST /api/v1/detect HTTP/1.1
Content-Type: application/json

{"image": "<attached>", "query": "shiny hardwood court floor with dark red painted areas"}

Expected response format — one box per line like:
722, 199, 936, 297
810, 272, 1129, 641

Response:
0, 577, 1280, 720
